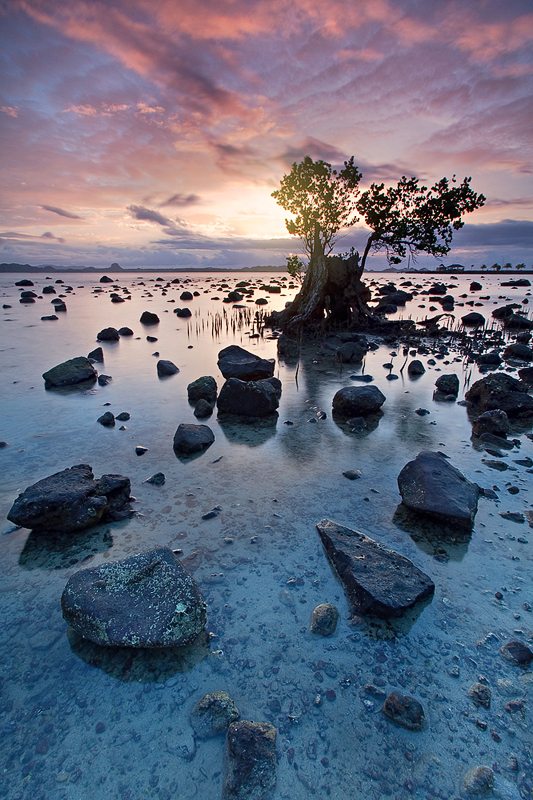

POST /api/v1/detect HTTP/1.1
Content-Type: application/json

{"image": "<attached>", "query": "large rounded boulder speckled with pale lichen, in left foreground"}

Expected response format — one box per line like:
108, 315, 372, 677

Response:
61, 547, 206, 648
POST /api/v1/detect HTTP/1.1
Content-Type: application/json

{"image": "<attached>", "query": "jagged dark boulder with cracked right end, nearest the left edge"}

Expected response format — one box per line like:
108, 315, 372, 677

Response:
7, 464, 131, 533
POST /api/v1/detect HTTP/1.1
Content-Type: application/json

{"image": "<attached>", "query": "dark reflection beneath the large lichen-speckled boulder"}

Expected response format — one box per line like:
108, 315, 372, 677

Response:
67, 628, 210, 683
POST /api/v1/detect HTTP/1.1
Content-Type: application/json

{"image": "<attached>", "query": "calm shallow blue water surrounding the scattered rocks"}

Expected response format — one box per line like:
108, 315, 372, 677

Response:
0, 272, 533, 800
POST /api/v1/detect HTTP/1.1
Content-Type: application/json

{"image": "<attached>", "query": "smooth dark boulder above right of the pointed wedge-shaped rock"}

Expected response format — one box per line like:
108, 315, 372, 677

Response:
398, 452, 480, 527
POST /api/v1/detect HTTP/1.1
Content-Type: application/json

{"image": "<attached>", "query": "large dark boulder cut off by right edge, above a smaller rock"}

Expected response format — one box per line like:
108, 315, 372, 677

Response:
465, 372, 533, 417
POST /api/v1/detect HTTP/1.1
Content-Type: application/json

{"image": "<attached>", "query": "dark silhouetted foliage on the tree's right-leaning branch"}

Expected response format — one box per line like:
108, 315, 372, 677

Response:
356, 175, 485, 268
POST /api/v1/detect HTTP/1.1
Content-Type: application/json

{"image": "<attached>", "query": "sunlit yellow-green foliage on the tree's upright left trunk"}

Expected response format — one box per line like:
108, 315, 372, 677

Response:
272, 156, 361, 258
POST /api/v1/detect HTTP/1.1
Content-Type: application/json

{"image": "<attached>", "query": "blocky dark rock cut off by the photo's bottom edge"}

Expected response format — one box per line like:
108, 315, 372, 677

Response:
222, 720, 276, 800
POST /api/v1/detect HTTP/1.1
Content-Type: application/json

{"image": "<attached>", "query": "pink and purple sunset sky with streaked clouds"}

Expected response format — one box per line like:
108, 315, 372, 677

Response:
0, 0, 533, 269
